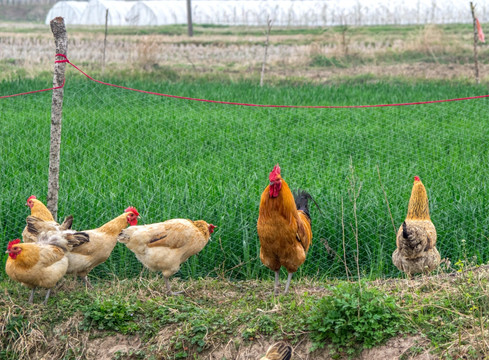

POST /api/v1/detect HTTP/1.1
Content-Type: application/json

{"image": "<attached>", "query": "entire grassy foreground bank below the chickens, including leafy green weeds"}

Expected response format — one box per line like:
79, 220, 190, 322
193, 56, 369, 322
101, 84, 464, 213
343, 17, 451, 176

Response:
0, 274, 489, 359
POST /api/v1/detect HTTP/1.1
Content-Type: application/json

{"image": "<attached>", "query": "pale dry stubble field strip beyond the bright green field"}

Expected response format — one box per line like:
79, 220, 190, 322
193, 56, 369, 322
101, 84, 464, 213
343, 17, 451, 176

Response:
0, 23, 489, 82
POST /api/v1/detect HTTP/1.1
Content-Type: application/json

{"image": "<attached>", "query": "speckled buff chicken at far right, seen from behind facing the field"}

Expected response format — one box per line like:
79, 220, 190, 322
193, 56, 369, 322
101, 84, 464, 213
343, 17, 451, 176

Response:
392, 176, 441, 277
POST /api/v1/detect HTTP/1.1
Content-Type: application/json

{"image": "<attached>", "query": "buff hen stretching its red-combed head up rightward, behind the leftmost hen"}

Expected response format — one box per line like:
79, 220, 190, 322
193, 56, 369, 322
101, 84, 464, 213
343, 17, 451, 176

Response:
61, 206, 139, 286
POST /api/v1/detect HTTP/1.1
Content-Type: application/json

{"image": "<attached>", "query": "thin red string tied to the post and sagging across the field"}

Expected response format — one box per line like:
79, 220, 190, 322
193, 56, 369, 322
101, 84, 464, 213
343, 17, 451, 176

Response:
0, 54, 489, 109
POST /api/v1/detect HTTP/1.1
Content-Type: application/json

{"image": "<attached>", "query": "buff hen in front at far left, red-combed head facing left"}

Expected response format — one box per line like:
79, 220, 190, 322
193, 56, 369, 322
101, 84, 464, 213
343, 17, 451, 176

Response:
5, 232, 88, 305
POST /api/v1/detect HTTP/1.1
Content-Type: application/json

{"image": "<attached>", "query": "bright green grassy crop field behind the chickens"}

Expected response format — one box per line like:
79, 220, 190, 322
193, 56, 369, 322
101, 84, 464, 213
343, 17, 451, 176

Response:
0, 76, 489, 279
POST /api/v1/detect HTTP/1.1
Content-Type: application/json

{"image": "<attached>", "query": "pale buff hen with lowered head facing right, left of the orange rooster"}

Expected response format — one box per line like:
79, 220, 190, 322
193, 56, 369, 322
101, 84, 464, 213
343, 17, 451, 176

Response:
117, 219, 215, 295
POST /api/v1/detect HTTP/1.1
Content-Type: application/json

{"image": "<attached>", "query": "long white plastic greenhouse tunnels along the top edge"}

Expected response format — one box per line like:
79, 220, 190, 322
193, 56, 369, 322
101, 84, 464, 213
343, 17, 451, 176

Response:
46, 0, 489, 26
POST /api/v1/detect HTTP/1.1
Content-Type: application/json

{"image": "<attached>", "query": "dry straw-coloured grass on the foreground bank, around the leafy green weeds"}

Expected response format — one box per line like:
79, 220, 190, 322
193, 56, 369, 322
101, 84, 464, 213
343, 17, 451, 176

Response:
0, 266, 489, 359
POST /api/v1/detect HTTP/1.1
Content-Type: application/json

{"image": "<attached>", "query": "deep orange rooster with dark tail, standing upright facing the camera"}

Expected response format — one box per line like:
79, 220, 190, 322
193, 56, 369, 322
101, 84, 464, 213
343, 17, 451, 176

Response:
257, 164, 312, 294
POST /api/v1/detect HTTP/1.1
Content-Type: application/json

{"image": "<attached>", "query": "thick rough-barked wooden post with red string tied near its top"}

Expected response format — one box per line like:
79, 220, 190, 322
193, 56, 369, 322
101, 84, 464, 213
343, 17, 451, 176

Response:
47, 17, 68, 220
